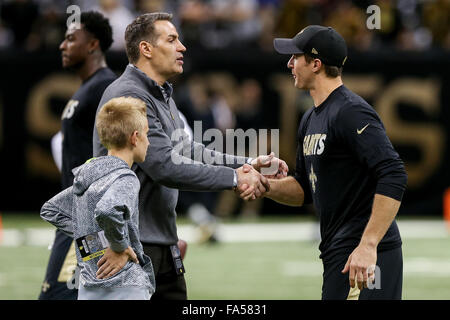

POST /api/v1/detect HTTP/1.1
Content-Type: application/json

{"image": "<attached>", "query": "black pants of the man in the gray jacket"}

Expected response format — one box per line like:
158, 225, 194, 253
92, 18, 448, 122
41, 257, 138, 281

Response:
142, 243, 187, 301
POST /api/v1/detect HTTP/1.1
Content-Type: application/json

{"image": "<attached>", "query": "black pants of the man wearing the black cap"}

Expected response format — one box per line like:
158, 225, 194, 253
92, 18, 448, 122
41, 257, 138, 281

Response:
322, 247, 403, 300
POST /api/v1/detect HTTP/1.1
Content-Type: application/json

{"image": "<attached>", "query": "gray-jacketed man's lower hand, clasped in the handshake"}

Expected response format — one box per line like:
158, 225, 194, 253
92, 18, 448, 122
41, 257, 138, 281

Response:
236, 164, 270, 200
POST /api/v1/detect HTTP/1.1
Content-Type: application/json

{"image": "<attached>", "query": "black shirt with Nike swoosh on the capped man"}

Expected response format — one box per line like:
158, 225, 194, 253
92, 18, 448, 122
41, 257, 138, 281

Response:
295, 85, 407, 259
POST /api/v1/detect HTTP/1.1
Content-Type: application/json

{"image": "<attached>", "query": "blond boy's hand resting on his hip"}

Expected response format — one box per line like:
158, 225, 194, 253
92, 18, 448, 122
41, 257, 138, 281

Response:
96, 247, 139, 279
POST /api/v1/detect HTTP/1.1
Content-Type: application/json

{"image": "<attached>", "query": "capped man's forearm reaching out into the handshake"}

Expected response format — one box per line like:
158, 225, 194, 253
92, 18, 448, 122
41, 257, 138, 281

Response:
264, 177, 305, 207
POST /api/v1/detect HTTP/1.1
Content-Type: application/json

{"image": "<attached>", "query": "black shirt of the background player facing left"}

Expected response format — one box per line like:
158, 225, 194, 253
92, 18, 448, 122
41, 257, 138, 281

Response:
61, 68, 117, 189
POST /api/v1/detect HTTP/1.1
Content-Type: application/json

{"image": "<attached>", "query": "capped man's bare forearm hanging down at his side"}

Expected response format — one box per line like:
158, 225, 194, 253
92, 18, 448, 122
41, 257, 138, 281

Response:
361, 194, 400, 248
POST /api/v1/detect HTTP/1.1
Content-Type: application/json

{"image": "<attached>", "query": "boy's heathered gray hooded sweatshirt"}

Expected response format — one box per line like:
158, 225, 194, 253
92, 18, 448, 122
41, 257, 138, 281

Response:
41, 156, 155, 294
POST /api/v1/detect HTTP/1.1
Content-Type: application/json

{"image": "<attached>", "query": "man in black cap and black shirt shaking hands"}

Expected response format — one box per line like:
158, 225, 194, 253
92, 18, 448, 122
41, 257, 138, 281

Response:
246, 25, 407, 299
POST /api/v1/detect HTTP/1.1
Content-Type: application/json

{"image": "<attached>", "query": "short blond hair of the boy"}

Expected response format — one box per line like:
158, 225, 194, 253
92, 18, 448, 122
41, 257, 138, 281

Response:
95, 97, 147, 149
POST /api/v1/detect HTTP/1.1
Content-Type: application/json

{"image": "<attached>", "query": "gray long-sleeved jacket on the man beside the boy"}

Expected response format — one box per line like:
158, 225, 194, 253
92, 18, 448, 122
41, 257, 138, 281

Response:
93, 64, 247, 245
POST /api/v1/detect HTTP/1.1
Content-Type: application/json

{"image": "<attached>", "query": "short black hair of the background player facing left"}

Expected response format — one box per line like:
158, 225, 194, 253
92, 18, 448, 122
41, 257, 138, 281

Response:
80, 11, 113, 52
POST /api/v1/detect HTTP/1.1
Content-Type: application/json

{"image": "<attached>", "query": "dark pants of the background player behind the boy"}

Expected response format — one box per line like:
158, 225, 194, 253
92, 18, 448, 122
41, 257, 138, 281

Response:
39, 230, 78, 300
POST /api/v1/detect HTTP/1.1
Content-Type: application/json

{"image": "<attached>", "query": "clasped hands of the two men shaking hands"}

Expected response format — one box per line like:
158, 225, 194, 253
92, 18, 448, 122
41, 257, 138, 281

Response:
235, 152, 289, 201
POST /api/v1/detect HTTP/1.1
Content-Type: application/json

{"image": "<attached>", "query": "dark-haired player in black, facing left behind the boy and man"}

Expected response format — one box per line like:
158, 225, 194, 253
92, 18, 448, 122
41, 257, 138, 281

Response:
39, 12, 116, 300
